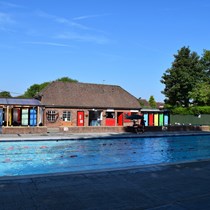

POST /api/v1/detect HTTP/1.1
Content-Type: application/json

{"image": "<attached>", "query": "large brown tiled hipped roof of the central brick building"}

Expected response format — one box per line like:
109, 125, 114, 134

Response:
38, 81, 140, 109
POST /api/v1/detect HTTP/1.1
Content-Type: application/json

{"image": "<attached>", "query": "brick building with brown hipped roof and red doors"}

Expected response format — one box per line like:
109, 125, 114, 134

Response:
36, 81, 141, 132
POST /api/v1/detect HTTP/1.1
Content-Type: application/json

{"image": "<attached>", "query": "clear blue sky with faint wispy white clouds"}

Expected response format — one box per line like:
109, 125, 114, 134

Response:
0, 0, 210, 101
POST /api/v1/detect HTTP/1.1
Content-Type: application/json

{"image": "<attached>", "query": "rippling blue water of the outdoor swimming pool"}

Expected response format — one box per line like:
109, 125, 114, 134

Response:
0, 135, 210, 176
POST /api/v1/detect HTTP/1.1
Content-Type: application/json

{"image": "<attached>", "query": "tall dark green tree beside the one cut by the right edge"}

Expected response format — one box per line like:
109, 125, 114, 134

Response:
161, 47, 204, 107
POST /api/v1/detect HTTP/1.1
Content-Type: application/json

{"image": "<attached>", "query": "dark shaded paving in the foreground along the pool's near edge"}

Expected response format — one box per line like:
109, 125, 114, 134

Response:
0, 132, 210, 210
